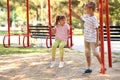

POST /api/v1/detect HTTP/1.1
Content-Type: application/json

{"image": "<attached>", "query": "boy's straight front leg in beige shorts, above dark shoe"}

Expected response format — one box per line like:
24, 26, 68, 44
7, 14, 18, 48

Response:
85, 41, 91, 68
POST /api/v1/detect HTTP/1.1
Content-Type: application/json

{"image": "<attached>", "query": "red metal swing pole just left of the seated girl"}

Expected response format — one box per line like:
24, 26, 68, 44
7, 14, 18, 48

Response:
48, 0, 52, 46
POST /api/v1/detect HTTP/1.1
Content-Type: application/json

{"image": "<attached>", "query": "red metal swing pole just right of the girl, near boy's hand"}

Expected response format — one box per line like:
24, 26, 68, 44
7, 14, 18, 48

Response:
69, 0, 73, 46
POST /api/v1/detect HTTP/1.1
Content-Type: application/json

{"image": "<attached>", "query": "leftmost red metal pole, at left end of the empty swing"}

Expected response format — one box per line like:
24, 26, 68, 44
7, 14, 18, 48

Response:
7, 0, 10, 46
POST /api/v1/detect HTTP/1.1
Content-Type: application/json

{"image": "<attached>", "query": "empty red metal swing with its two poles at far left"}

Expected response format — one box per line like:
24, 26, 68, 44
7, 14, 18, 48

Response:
3, 0, 30, 48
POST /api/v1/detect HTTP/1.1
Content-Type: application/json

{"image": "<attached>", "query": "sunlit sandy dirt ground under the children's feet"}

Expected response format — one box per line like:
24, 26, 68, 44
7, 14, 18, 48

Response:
0, 51, 120, 80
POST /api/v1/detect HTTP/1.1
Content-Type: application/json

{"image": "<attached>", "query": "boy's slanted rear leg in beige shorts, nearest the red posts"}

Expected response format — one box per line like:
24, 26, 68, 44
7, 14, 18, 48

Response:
90, 42, 101, 64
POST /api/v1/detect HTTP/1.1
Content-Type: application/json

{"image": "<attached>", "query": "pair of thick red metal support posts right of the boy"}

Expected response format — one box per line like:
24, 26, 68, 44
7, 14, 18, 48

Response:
99, 0, 112, 74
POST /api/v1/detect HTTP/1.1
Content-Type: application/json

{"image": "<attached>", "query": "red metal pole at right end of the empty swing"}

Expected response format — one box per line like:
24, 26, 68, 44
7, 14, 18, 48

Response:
26, 0, 30, 47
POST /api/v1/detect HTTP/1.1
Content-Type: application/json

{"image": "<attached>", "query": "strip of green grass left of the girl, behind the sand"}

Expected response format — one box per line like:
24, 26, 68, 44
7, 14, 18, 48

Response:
0, 45, 49, 55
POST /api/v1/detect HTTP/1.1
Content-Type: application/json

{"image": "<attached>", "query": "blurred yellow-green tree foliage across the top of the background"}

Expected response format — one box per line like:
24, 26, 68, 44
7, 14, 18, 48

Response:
0, 0, 120, 27
